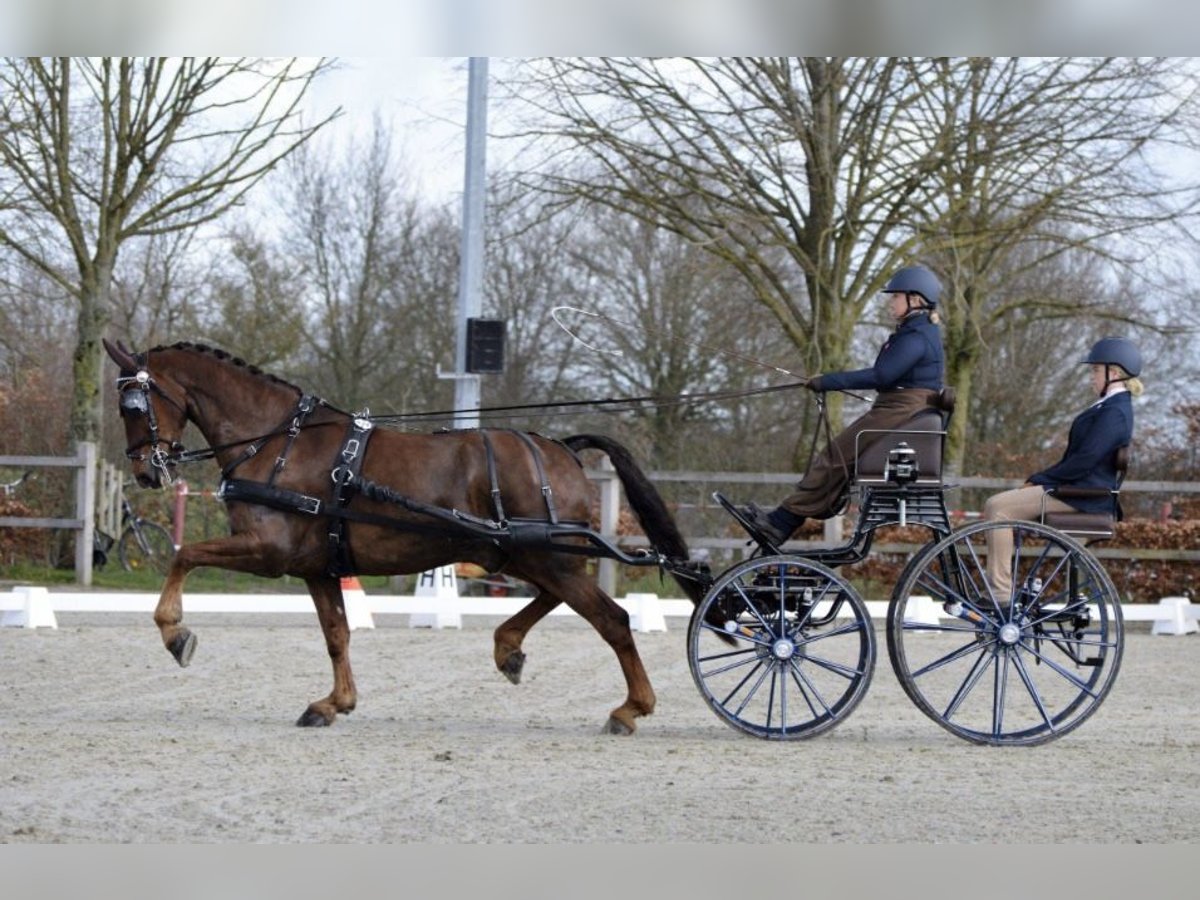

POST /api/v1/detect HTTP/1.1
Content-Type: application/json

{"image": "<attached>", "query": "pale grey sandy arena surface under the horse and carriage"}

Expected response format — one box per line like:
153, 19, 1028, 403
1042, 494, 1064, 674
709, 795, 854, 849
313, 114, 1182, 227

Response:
0, 614, 1200, 844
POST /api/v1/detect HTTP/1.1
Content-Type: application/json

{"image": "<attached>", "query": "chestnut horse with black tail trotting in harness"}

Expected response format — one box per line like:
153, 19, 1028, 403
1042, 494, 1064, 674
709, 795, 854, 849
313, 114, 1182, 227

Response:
104, 341, 703, 734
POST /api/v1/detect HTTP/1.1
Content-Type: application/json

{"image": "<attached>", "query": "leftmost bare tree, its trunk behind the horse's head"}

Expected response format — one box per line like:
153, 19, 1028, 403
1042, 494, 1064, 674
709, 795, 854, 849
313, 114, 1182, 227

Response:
0, 56, 336, 439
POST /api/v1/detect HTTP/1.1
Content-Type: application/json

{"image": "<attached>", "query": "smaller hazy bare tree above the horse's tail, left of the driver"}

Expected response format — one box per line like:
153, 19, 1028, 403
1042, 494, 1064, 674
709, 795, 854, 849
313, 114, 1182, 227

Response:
556, 209, 808, 468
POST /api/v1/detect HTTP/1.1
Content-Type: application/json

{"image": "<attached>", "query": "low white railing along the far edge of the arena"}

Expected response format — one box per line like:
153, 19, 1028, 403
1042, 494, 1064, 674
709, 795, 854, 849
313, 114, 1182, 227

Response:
0, 586, 1200, 635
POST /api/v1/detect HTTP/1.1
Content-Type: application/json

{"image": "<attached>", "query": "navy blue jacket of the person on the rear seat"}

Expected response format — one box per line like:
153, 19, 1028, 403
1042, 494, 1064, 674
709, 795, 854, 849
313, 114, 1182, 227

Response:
1027, 391, 1133, 512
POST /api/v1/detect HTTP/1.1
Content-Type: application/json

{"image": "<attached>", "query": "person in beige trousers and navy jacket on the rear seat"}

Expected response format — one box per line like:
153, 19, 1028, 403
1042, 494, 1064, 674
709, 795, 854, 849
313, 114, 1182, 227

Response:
983, 337, 1142, 600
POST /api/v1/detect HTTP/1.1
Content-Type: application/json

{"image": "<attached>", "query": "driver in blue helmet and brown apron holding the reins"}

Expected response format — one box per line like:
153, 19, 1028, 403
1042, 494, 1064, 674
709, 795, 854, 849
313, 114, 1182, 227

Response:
740, 265, 946, 545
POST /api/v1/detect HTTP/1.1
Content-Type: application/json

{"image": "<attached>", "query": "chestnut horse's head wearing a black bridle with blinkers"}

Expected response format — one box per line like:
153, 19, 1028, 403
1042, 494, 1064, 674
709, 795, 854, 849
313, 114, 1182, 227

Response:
103, 340, 187, 487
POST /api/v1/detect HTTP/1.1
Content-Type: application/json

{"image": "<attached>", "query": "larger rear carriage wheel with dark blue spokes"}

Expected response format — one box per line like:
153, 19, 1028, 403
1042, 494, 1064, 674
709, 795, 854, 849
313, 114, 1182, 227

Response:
887, 522, 1124, 745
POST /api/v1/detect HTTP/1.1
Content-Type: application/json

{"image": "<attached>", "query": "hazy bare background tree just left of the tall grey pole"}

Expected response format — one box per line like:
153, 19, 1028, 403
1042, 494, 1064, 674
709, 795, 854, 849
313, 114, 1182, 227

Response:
263, 118, 458, 415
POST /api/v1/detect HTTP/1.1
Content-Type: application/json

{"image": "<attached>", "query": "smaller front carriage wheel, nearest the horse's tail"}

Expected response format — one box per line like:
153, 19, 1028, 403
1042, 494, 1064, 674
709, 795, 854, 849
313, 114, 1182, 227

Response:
688, 556, 875, 740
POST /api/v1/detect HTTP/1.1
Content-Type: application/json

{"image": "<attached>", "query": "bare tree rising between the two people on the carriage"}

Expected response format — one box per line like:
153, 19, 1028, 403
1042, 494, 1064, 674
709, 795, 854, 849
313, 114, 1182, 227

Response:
914, 58, 1200, 468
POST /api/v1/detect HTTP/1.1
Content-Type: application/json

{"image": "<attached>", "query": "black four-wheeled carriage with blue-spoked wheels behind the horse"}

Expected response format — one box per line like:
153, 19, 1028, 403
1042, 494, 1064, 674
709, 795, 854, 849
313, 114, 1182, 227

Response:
688, 401, 1124, 745
